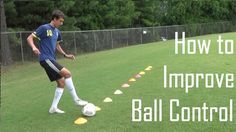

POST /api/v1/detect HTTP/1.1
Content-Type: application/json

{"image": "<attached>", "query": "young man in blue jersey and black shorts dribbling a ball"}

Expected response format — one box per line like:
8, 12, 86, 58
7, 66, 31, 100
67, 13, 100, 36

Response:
27, 10, 88, 114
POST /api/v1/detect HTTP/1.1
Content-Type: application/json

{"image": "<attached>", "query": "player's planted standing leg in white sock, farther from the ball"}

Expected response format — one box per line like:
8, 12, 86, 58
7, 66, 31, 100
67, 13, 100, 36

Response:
49, 77, 65, 114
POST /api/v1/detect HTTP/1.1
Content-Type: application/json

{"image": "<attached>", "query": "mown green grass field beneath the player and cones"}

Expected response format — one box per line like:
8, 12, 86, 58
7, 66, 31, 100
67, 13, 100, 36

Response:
0, 33, 236, 132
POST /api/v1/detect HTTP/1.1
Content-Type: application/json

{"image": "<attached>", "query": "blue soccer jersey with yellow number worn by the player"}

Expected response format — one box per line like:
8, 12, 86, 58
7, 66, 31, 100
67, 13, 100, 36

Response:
33, 24, 62, 61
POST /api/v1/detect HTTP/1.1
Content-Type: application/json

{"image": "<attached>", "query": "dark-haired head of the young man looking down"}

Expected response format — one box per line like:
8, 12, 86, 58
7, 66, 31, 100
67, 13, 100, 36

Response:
51, 10, 65, 27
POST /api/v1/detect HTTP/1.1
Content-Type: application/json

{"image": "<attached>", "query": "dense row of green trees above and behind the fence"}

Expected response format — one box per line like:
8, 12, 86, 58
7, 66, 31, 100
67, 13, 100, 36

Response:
4, 0, 236, 30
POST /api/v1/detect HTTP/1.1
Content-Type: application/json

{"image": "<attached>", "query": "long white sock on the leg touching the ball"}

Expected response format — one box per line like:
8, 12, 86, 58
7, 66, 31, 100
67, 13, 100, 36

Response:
65, 77, 79, 100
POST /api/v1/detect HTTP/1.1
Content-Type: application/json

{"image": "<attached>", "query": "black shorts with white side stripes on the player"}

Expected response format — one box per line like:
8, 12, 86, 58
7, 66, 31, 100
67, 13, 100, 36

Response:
40, 59, 63, 82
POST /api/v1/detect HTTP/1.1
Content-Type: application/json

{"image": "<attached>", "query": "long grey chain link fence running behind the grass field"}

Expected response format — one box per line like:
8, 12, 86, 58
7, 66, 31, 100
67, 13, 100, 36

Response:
1, 21, 235, 65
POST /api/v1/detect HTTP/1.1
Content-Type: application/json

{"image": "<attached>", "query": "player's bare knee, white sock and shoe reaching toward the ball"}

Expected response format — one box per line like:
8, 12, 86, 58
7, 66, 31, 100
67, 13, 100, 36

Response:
60, 68, 88, 106
